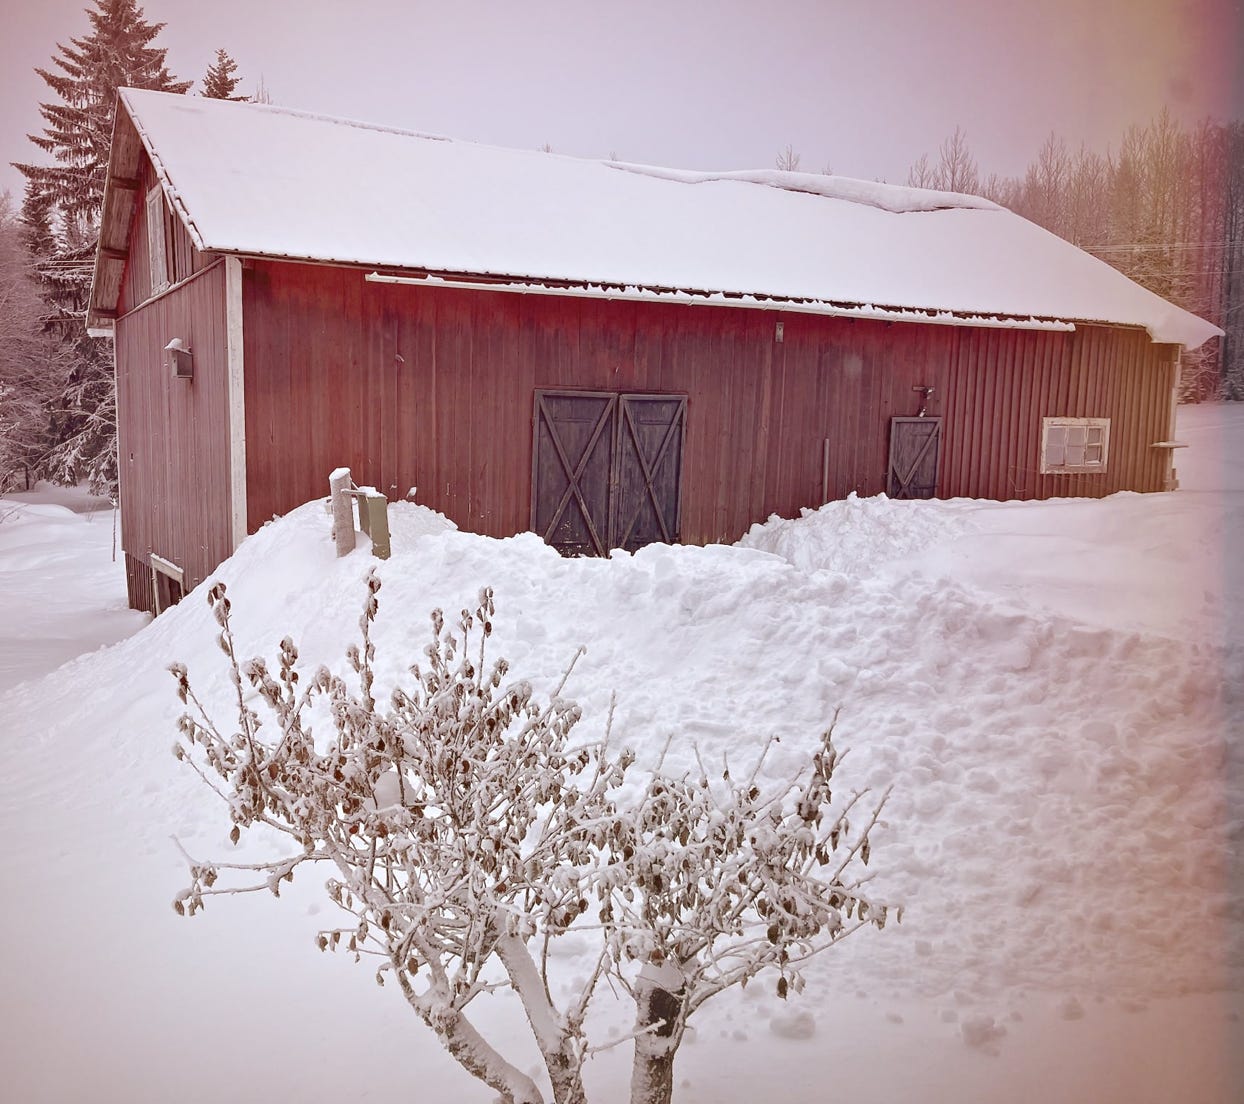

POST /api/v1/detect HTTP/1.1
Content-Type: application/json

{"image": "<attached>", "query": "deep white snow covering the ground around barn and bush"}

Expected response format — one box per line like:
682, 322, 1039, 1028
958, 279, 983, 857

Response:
0, 406, 1244, 1104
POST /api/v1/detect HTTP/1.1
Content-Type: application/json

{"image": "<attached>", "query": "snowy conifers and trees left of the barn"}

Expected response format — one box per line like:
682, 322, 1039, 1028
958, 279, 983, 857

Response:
0, 0, 250, 494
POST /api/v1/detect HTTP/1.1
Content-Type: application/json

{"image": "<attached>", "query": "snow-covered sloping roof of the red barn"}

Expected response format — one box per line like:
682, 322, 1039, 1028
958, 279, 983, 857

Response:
91, 90, 1220, 347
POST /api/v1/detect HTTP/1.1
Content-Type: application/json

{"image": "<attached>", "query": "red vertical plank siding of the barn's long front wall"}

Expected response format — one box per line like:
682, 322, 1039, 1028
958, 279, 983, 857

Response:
243, 261, 1169, 552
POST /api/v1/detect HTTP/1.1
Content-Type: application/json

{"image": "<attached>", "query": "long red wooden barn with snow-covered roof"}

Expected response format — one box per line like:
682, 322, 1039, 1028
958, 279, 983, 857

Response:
88, 91, 1218, 609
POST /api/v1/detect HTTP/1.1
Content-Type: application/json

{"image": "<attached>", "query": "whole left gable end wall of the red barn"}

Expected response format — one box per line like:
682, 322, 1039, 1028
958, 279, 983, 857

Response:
93, 129, 236, 609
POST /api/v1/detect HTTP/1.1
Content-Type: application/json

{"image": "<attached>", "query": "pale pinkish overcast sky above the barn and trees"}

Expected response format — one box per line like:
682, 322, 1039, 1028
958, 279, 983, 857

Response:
0, 0, 1244, 200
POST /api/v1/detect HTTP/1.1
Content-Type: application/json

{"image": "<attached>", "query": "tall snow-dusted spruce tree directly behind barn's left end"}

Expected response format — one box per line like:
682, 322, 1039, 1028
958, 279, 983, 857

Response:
16, 0, 192, 490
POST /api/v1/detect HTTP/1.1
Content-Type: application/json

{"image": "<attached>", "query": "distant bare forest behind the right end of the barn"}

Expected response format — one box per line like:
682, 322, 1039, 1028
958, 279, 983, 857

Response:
905, 111, 1244, 402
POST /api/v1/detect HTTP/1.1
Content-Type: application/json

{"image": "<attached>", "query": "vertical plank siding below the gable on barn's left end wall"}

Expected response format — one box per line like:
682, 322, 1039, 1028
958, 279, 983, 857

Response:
116, 261, 233, 609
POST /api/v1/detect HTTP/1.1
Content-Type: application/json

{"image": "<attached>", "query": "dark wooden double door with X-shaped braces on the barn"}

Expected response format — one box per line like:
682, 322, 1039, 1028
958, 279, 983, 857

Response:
531, 391, 687, 556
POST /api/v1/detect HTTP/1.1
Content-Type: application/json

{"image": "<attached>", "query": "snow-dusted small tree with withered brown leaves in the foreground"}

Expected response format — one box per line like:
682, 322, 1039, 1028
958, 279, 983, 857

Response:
170, 574, 888, 1104
